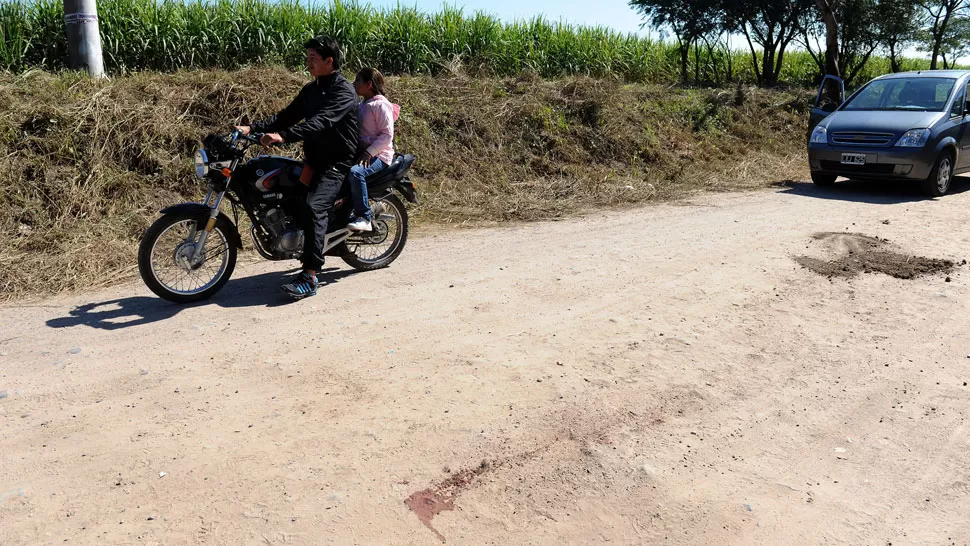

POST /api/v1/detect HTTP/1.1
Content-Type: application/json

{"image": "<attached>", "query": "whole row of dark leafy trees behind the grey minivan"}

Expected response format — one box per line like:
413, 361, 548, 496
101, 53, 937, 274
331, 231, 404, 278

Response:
629, 0, 970, 86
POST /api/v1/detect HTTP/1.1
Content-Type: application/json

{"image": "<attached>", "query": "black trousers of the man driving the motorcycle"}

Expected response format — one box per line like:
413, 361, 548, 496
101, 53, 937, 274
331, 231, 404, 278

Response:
302, 167, 350, 271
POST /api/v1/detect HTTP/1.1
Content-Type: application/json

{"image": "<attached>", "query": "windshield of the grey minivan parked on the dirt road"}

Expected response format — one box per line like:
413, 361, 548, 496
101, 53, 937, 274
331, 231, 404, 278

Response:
842, 77, 956, 112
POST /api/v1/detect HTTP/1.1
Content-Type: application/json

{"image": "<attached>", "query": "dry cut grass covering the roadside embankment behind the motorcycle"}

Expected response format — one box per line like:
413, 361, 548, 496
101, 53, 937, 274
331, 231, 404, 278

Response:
0, 68, 808, 298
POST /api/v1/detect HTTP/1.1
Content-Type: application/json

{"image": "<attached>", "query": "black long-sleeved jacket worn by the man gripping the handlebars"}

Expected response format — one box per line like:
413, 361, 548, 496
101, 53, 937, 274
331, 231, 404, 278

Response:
252, 72, 359, 172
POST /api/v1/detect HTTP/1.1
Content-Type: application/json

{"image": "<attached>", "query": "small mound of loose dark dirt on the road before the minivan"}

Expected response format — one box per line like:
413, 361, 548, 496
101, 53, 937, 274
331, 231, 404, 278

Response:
795, 233, 956, 279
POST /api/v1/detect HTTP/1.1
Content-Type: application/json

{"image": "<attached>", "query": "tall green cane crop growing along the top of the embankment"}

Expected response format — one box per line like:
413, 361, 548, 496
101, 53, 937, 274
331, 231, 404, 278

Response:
0, 0, 925, 86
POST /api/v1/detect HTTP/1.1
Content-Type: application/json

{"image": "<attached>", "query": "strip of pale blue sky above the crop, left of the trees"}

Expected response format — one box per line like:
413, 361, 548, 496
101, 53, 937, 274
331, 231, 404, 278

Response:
361, 0, 656, 35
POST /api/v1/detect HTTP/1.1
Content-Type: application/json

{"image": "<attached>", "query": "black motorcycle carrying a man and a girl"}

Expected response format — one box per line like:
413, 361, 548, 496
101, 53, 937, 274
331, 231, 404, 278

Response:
138, 131, 417, 303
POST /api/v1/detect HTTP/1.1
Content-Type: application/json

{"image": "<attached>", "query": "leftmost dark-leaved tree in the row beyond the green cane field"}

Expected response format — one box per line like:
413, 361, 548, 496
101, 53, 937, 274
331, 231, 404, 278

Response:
630, 0, 722, 82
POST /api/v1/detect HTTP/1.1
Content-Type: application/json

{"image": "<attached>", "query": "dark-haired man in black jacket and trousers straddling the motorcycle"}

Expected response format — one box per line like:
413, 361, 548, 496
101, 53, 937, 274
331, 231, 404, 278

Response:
237, 36, 358, 299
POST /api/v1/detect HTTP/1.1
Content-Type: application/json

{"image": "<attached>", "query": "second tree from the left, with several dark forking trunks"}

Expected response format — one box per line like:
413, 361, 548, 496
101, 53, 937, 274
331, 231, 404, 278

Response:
722, 0, 812, 86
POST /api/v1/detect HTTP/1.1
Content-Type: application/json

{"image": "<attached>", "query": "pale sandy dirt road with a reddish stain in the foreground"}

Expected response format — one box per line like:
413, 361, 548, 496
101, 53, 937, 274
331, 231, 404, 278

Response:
0, 183, 970, 546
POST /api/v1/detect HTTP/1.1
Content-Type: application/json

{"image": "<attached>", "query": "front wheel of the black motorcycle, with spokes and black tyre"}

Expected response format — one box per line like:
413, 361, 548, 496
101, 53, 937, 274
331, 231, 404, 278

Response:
138, 214, 236, 303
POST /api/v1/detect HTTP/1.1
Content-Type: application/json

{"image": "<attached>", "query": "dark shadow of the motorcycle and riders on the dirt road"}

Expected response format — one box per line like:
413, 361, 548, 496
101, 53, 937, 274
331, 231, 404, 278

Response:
47, 267, 357, 330
